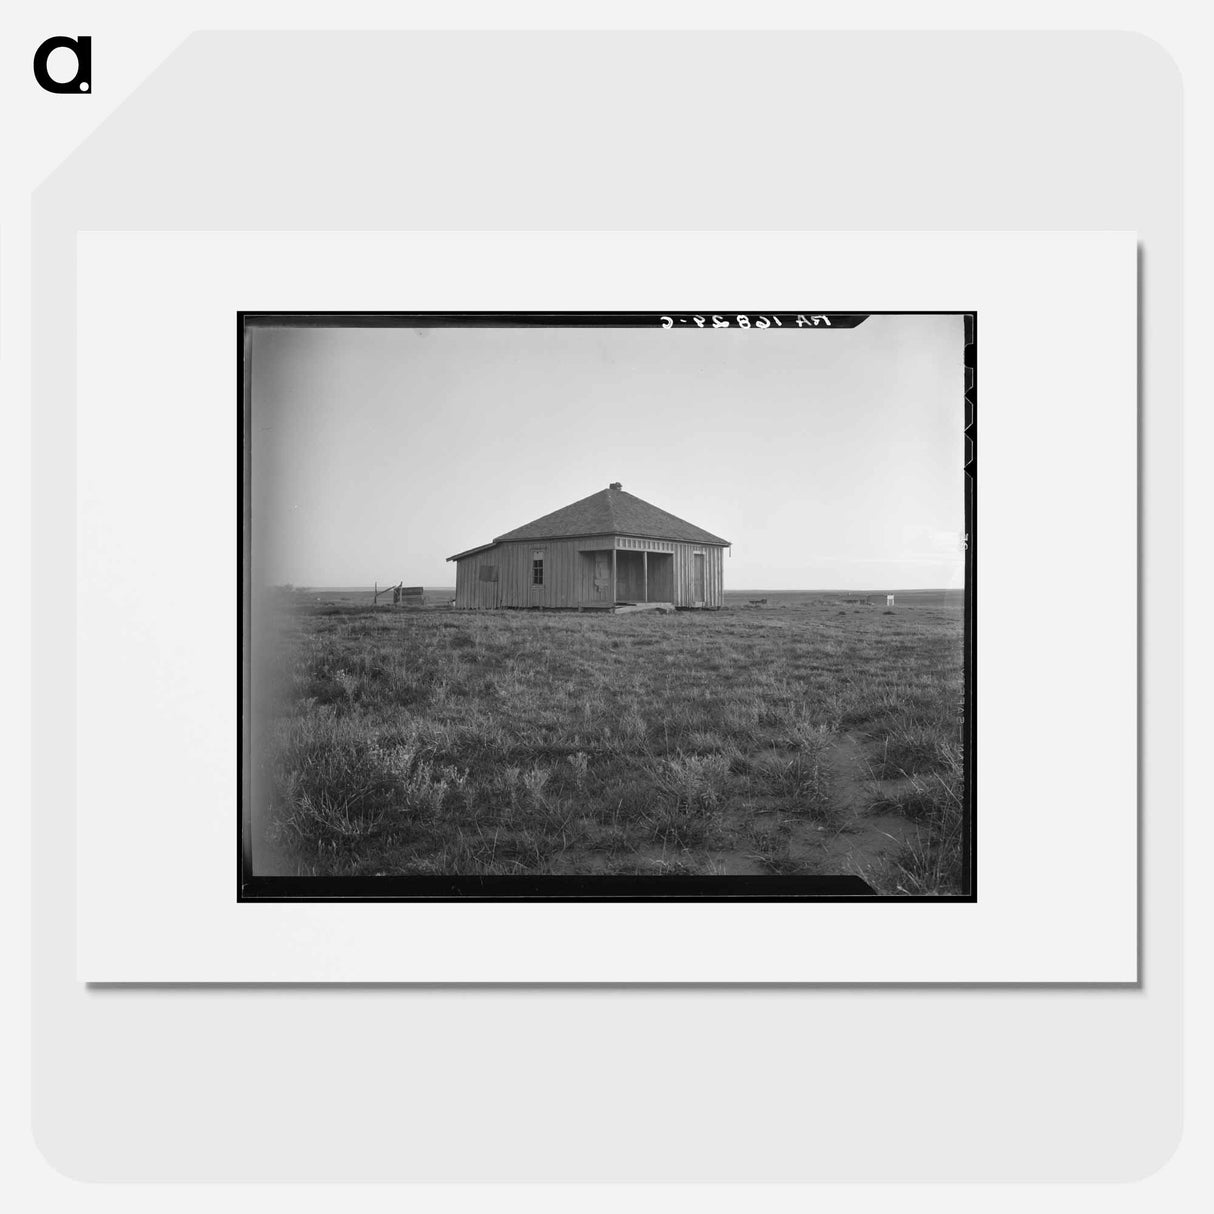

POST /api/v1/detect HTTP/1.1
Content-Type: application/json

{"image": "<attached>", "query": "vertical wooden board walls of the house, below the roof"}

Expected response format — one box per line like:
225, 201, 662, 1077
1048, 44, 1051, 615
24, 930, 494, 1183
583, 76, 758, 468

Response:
455, 535, 725, 609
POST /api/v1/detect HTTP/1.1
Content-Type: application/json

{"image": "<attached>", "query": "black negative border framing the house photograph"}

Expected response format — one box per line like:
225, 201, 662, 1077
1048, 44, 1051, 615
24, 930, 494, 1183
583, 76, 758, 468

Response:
236, 308, 978, 904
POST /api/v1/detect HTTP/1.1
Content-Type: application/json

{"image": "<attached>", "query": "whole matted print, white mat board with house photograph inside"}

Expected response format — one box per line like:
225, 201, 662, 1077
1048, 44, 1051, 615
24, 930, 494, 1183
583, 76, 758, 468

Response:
76, 232, 1136, 982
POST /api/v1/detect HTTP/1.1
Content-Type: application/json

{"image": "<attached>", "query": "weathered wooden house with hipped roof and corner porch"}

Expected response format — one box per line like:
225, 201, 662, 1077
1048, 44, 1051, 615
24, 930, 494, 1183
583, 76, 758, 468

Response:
447, 482, 730, 611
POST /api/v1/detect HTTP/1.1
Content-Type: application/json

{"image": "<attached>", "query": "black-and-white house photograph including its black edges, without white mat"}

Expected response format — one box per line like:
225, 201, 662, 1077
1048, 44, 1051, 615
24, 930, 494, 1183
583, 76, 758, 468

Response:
238, 311, 977, 900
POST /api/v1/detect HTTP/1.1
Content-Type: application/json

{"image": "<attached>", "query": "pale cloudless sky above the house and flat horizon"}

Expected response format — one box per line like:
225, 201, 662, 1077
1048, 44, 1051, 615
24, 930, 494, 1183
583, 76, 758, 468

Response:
250, 316, 965, 590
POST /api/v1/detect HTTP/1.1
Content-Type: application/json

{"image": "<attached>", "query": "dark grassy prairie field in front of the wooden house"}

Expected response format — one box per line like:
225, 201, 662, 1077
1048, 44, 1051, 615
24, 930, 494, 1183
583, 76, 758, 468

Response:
254, 591, 965, 895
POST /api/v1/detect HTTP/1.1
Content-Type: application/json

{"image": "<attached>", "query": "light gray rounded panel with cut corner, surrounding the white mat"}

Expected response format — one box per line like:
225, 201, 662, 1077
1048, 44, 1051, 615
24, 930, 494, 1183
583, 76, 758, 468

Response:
33, 33, 1180, 1180
